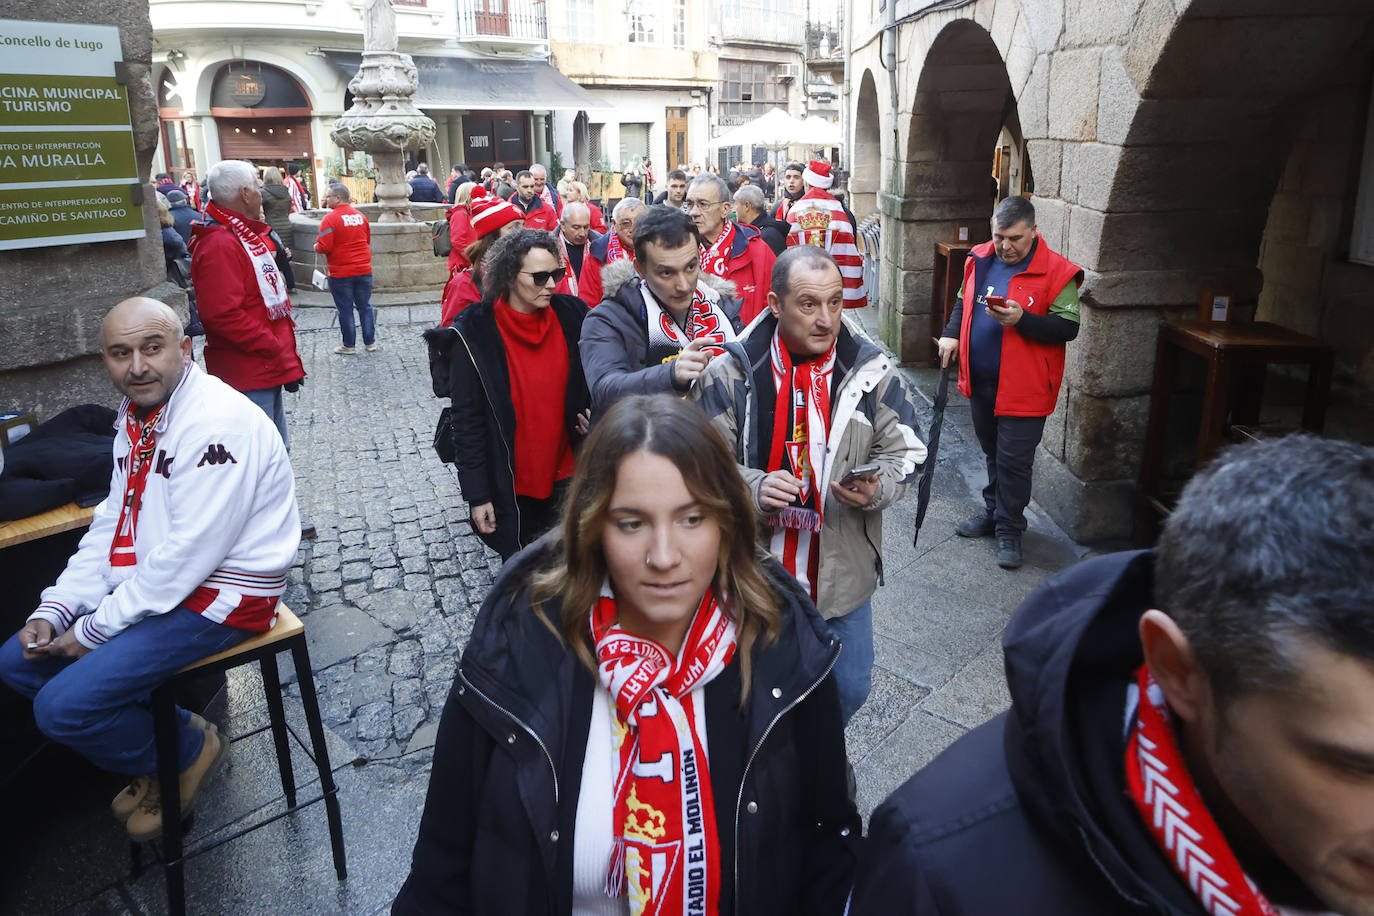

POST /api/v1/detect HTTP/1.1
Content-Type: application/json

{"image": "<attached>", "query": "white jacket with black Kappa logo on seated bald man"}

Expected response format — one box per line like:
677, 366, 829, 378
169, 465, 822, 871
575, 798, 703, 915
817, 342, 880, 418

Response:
29, 365, 301, 648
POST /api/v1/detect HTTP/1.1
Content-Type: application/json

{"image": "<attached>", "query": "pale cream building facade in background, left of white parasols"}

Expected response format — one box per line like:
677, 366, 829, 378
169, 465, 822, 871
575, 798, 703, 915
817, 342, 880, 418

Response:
548, 0, 717, 185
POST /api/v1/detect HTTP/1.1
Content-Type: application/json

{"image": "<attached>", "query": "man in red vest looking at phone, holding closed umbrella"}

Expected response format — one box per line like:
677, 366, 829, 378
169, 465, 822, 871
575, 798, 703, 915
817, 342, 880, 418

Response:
938, 196, 1083, 570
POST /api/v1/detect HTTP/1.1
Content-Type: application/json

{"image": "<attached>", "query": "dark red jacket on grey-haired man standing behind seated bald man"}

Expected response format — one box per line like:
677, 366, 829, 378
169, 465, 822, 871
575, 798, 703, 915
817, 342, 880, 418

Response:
191, 220, 305, 391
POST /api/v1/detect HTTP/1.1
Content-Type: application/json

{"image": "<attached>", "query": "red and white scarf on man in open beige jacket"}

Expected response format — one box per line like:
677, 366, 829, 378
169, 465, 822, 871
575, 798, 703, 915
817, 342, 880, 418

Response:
767, 325, 835, 600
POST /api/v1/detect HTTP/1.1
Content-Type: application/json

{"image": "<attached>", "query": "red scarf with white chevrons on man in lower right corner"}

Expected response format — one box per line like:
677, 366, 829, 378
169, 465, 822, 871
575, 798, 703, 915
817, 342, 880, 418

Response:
1125, 665, 1278, 916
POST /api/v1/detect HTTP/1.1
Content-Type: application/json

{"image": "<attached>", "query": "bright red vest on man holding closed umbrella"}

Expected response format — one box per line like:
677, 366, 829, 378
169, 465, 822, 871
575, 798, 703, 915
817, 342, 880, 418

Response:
959, 233, 1083, 416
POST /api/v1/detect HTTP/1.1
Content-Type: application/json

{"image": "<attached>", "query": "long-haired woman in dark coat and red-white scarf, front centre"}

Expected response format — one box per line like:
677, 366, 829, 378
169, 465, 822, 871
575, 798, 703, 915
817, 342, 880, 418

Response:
392, 394, 861, 916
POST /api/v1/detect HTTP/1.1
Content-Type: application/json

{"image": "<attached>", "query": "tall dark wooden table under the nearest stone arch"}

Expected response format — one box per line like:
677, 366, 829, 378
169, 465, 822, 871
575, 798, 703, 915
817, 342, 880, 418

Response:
1140, 321, 1336, 515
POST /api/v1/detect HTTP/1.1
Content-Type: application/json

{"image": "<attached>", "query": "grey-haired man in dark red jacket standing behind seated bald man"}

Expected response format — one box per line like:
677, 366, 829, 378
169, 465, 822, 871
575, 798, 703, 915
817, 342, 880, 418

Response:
190, 159, 305, 444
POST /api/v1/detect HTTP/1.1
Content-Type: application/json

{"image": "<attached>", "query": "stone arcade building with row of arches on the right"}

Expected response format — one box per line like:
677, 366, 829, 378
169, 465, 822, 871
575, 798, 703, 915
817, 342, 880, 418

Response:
846, 0, 1374, 541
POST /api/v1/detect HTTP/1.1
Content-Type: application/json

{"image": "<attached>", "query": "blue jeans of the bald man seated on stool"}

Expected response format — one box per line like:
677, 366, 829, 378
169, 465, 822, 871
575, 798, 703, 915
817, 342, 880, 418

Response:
0, 607, 253, 776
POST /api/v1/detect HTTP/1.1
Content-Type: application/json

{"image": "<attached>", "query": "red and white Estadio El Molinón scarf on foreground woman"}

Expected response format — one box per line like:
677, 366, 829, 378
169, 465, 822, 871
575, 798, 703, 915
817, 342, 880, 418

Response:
591, 584, 735, 916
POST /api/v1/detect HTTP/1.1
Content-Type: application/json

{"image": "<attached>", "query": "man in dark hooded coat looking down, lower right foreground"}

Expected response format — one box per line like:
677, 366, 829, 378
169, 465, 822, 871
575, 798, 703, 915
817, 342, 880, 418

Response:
849, 437, 1374, 916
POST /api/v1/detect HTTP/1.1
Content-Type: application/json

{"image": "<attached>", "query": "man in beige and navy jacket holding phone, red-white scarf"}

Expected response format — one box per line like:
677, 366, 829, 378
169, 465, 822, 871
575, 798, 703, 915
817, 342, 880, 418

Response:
691, 246, 926, 722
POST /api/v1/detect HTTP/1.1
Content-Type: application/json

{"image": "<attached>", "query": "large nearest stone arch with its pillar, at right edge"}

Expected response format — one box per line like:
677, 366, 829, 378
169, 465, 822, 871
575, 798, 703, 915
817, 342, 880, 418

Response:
1036, 0, 1374, 540
